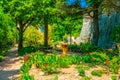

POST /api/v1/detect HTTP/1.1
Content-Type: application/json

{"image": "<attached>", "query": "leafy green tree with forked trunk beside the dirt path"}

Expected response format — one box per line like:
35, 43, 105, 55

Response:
1, 0, 38, 50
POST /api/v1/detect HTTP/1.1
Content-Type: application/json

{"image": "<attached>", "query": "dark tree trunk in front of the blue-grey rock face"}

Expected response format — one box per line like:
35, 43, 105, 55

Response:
93, 4, 99, 46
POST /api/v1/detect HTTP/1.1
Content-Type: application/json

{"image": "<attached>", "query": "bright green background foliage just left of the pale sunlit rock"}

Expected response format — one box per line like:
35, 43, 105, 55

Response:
52, 16, 82, 41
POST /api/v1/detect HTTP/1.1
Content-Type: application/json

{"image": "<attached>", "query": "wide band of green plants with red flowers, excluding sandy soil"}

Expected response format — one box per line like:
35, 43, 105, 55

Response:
21, 49, 120, 80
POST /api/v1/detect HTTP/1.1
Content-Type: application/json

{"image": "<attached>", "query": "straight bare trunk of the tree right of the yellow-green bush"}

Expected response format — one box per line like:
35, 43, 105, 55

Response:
44, 18, 48, 48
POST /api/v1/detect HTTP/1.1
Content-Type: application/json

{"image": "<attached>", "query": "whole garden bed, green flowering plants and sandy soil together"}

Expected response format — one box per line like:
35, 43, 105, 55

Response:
21, 52, 120, 80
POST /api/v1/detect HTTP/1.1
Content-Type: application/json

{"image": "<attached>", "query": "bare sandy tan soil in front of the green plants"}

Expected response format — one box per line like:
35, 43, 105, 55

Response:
29, 65, 118, 80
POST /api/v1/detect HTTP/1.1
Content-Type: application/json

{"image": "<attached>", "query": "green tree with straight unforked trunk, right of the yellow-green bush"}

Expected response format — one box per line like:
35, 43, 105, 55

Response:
33, 0, 60, 48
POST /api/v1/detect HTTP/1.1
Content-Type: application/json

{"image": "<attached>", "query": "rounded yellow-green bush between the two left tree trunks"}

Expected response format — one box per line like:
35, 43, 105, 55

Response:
24, 26, 43, 46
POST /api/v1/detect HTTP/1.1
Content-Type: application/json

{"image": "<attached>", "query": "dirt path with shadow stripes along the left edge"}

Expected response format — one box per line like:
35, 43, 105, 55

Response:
0, 48, 22, 80
